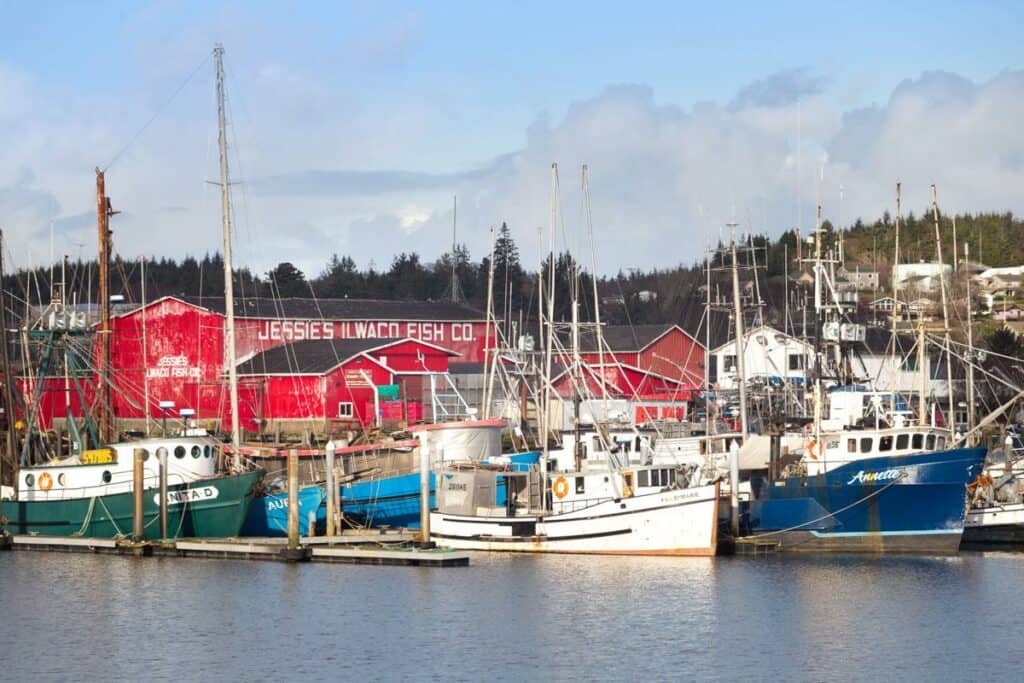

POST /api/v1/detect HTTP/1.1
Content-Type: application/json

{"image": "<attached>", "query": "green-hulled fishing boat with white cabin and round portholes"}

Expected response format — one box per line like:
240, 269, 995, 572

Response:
0, 435, 263, 540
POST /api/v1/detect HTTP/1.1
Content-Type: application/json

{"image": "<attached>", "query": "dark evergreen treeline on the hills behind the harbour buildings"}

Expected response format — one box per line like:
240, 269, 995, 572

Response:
5, 212, 1024, 327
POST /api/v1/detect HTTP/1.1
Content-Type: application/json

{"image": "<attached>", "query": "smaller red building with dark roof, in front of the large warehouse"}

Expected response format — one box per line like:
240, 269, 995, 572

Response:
234, 338, 458, 431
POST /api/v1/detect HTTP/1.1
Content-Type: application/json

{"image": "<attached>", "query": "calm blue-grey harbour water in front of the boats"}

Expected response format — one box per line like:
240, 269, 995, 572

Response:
0, 552, 1024, 681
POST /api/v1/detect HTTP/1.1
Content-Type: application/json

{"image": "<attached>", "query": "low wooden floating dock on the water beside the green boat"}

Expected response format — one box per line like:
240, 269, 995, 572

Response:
0, 529, 470, 567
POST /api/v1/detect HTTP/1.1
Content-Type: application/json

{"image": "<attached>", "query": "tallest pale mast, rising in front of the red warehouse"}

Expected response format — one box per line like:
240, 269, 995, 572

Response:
213, 43, 242, 469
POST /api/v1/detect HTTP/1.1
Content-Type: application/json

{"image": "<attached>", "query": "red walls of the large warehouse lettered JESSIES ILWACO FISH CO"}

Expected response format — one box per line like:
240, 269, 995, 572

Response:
78, 296, 495, 424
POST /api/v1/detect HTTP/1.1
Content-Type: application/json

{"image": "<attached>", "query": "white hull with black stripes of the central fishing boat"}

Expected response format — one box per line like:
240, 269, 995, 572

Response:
430, 484, 718, 556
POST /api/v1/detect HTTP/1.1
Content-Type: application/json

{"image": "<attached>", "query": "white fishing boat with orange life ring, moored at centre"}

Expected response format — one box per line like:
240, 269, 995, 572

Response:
430, 466, 719, 556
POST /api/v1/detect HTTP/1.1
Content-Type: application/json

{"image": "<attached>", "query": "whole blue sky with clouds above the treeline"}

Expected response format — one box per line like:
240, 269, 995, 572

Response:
0, 0, 1024, 276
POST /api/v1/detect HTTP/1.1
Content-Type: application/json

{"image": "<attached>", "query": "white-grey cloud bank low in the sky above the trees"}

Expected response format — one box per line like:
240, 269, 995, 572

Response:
0, 61, 1024, 273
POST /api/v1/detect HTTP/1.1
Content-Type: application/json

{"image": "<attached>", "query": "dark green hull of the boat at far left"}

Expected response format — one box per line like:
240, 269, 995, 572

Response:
0, 471, 263, 541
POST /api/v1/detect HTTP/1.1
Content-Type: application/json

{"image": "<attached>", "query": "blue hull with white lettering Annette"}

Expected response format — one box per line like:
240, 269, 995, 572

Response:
738, 449, 985, 554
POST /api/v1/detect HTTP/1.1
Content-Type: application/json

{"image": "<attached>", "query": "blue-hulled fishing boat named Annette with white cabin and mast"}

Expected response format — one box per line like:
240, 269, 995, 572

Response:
737, 195, 986, 554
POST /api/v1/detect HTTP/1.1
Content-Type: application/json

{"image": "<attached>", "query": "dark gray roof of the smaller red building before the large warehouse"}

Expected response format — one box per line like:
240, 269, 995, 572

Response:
239, 339, 402, 375
